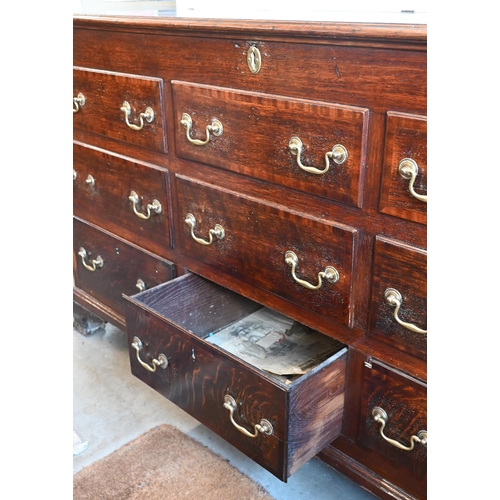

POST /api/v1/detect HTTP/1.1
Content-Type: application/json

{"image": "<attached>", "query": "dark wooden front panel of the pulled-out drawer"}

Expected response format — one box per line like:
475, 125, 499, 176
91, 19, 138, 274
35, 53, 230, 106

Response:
126, 300, 285, 479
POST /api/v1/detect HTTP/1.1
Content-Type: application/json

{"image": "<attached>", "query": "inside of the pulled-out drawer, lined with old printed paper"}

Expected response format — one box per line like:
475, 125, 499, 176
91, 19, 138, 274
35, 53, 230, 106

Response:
130, 274, 347, 385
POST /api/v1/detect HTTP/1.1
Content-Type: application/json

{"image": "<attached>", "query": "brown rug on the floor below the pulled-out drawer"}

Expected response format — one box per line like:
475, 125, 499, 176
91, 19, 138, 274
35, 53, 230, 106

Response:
73, 425, 273, 500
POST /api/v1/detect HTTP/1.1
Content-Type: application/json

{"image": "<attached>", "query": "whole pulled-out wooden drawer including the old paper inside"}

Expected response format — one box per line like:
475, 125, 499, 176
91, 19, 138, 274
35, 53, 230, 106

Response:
124, 274, 347, 481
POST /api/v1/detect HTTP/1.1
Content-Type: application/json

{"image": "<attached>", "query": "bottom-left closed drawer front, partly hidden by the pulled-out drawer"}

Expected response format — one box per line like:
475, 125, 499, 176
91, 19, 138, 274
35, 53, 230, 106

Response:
73, 218, 175, 316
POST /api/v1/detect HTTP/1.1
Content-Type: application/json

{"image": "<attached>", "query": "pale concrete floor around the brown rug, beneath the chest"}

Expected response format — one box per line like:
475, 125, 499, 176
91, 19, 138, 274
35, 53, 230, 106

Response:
73, 324, 376, 500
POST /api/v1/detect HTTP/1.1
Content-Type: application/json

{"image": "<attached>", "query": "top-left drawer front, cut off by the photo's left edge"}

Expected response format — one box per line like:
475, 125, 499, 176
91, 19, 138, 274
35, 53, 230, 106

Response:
73, 67, 167, 152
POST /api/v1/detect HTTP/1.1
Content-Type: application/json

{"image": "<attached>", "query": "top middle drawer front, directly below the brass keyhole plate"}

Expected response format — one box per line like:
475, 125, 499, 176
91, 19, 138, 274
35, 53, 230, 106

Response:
172, 82, 368, 207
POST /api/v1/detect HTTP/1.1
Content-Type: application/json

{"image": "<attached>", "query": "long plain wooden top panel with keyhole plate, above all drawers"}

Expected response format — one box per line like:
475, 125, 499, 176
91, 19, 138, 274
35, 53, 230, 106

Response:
74, 28, 427, 112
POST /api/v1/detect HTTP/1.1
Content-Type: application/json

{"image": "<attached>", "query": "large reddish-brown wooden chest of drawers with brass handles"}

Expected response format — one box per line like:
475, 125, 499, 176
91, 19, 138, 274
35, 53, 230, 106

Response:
73, 16, 427, 499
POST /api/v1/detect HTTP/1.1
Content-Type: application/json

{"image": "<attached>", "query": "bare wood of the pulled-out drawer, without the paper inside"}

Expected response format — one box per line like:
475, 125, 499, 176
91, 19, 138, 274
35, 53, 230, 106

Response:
126, 274, 346, 481
